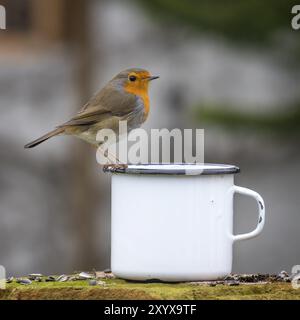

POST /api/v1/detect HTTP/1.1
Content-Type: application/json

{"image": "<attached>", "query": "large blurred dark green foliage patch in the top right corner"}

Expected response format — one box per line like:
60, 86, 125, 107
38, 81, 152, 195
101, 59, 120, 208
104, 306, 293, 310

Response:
138, 0, 299, 42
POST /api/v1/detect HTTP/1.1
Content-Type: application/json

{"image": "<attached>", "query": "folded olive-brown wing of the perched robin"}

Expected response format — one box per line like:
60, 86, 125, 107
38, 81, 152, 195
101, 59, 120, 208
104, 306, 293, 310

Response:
59, 83, 136, 127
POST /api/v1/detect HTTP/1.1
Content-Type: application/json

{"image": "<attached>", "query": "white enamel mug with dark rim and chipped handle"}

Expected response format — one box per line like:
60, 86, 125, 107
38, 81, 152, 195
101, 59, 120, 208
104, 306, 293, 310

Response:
105, 164, 265, 281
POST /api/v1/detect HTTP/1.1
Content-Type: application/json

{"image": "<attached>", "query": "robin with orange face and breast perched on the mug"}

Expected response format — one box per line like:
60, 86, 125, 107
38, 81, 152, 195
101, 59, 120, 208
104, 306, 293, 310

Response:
25, 68, 159, 161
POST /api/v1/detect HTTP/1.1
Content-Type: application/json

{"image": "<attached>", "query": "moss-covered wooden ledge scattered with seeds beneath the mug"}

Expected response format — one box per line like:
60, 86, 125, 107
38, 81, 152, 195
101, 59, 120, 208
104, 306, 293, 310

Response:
0, 279, 300, 300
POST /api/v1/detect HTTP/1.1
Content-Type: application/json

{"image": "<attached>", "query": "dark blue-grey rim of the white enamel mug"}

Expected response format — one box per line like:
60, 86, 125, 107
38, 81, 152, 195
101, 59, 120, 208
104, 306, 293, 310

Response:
103, 163, 240, 175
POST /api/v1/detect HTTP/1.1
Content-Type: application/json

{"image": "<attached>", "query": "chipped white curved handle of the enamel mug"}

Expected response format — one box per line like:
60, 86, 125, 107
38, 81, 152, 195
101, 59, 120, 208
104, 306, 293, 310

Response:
232, 186, 265, 241
